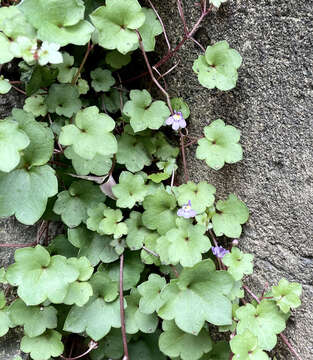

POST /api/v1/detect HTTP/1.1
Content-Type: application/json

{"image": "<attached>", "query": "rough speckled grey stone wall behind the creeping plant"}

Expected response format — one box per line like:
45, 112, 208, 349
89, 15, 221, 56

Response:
0, 0, 313, 360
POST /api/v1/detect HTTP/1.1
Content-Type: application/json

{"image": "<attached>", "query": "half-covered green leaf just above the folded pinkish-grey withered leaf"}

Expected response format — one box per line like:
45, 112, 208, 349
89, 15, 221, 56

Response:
64, 146, 112, 176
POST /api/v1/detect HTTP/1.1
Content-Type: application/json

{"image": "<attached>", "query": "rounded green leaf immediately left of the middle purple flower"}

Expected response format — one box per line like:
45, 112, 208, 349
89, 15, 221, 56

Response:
142, 190, 177, 235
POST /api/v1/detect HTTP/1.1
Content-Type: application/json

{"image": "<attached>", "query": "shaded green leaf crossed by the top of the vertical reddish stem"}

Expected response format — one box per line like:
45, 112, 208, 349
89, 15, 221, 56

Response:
104, 251, 144, 291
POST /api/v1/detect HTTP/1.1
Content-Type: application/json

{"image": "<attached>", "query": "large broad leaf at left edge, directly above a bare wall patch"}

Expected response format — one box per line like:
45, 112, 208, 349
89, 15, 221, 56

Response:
0, 165, 58, 225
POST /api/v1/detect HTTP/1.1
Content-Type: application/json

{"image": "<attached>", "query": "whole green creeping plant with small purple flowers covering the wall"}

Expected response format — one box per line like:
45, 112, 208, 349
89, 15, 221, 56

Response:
0, 0, 301, 360
